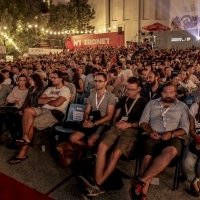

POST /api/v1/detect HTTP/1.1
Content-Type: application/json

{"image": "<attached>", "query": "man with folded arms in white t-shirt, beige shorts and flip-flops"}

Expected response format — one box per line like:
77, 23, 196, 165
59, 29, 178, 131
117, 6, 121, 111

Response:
9, 71, 71, 164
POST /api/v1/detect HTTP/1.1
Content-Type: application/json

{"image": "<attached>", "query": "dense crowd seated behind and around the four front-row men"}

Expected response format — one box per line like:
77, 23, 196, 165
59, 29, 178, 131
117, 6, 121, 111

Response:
0, 45, 200, 199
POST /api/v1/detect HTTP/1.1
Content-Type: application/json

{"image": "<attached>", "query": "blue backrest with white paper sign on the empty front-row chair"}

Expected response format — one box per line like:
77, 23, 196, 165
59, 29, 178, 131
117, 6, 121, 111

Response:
66, 103, 86, 122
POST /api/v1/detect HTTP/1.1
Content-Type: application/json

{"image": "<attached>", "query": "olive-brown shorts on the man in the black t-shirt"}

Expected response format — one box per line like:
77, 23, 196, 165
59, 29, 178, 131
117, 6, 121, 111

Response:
101, 126, 138, 158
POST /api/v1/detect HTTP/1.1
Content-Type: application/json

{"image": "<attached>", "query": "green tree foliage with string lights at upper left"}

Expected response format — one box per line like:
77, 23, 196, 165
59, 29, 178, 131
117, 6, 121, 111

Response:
0, 0, 95, 54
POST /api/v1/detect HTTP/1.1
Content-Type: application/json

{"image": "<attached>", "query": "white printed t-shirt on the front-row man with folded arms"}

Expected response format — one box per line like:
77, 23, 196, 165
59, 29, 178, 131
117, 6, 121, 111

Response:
43, 86, 71, 113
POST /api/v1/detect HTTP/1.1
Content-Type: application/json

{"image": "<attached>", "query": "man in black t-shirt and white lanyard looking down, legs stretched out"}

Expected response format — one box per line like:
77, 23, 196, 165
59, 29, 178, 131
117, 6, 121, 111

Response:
79, 77, 147, 196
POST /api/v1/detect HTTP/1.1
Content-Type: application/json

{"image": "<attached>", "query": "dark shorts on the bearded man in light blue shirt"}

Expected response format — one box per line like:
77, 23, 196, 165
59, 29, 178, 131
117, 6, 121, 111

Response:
141, 134, 184, 158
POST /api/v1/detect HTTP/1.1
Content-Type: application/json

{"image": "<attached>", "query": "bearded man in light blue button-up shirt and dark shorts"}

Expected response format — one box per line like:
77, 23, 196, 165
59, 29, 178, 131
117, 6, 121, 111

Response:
130, 82, 189, 200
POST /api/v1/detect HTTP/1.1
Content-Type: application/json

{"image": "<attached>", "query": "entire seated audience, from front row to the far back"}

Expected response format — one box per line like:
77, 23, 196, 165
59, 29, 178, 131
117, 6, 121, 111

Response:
0, 44, 200, 200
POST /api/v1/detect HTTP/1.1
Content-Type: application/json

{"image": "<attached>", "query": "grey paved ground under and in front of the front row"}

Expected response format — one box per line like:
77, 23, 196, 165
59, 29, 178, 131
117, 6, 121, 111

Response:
0, 130, 196, 200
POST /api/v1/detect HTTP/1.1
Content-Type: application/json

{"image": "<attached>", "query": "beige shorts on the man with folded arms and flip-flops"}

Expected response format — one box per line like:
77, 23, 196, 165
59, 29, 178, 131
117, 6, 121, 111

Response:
32, 107, 58, 131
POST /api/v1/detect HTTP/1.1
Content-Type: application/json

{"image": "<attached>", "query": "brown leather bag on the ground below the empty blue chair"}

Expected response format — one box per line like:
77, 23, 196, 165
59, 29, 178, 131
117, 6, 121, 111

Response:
56, 142, 82, 167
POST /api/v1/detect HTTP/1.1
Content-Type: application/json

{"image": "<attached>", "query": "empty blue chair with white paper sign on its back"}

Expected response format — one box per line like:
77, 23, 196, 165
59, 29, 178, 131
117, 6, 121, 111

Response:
55, 103, 86, 134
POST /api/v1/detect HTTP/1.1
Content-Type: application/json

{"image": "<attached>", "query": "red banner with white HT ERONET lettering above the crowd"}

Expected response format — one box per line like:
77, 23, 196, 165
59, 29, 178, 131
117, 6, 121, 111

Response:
66, 32, 124, 49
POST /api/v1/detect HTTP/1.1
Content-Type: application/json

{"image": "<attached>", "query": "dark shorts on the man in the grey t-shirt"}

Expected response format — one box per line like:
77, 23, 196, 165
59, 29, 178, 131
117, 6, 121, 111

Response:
75, 122, 108, 137
